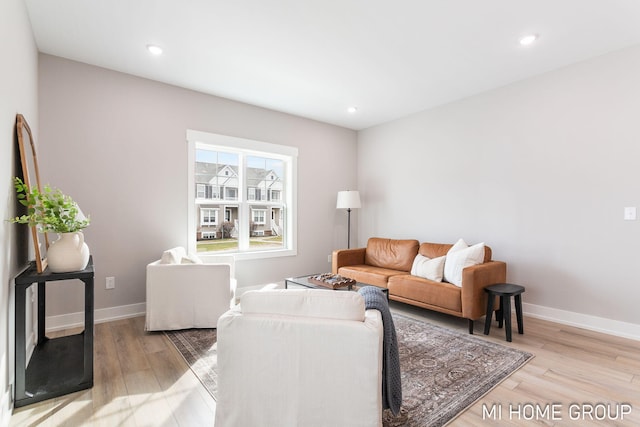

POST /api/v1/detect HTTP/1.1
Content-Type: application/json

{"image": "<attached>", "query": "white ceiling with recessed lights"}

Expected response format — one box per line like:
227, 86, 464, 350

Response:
25, 0, 640, 130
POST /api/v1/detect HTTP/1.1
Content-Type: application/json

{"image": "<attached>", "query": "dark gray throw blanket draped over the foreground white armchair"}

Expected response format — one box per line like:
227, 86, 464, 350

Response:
358, 286, 402, 415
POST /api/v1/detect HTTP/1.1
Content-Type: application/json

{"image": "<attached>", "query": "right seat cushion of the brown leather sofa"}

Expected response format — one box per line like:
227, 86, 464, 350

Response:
389, 275, 462, 312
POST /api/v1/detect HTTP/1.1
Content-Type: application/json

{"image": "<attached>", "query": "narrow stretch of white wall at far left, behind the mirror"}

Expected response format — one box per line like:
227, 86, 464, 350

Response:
0, 0, 38, 425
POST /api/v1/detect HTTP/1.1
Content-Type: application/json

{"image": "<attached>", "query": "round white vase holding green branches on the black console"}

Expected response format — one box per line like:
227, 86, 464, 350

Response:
47, 231, 89, 273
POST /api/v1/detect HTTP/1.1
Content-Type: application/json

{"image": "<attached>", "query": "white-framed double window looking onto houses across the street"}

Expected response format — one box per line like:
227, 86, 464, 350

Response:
187, 130, 298, 259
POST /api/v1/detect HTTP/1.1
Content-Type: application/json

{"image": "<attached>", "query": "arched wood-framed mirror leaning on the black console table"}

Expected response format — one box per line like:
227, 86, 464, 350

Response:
16, 114, 49, 273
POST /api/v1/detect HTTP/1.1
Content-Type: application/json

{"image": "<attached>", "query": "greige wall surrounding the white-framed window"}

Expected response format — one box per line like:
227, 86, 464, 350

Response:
39, 55, 356, 316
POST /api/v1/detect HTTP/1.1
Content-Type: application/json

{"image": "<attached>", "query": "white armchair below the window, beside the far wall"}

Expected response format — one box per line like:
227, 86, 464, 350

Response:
145, 247, 236, 331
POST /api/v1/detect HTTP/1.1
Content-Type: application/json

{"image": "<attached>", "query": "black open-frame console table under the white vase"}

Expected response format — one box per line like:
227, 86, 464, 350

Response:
14, 258, 94, 407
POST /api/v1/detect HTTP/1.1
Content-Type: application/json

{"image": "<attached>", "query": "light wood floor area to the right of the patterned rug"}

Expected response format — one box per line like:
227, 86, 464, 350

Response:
393, 304, 640, 427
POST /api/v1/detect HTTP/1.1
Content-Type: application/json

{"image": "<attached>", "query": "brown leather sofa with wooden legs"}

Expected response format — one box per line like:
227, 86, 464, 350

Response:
332, 237, 507, 334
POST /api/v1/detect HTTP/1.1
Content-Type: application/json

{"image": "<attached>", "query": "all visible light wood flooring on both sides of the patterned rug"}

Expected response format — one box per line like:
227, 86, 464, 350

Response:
10, 301, 640, 427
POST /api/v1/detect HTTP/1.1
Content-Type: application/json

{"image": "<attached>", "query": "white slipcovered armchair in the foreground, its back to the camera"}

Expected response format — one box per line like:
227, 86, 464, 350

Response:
215, 289, 383, 427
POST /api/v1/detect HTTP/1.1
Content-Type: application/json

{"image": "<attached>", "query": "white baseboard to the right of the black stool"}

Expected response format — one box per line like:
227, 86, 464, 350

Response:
522, 303, 640, 341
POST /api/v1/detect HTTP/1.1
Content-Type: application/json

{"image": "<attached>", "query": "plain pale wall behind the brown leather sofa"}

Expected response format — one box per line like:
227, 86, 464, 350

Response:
358, 46, 640, 338
